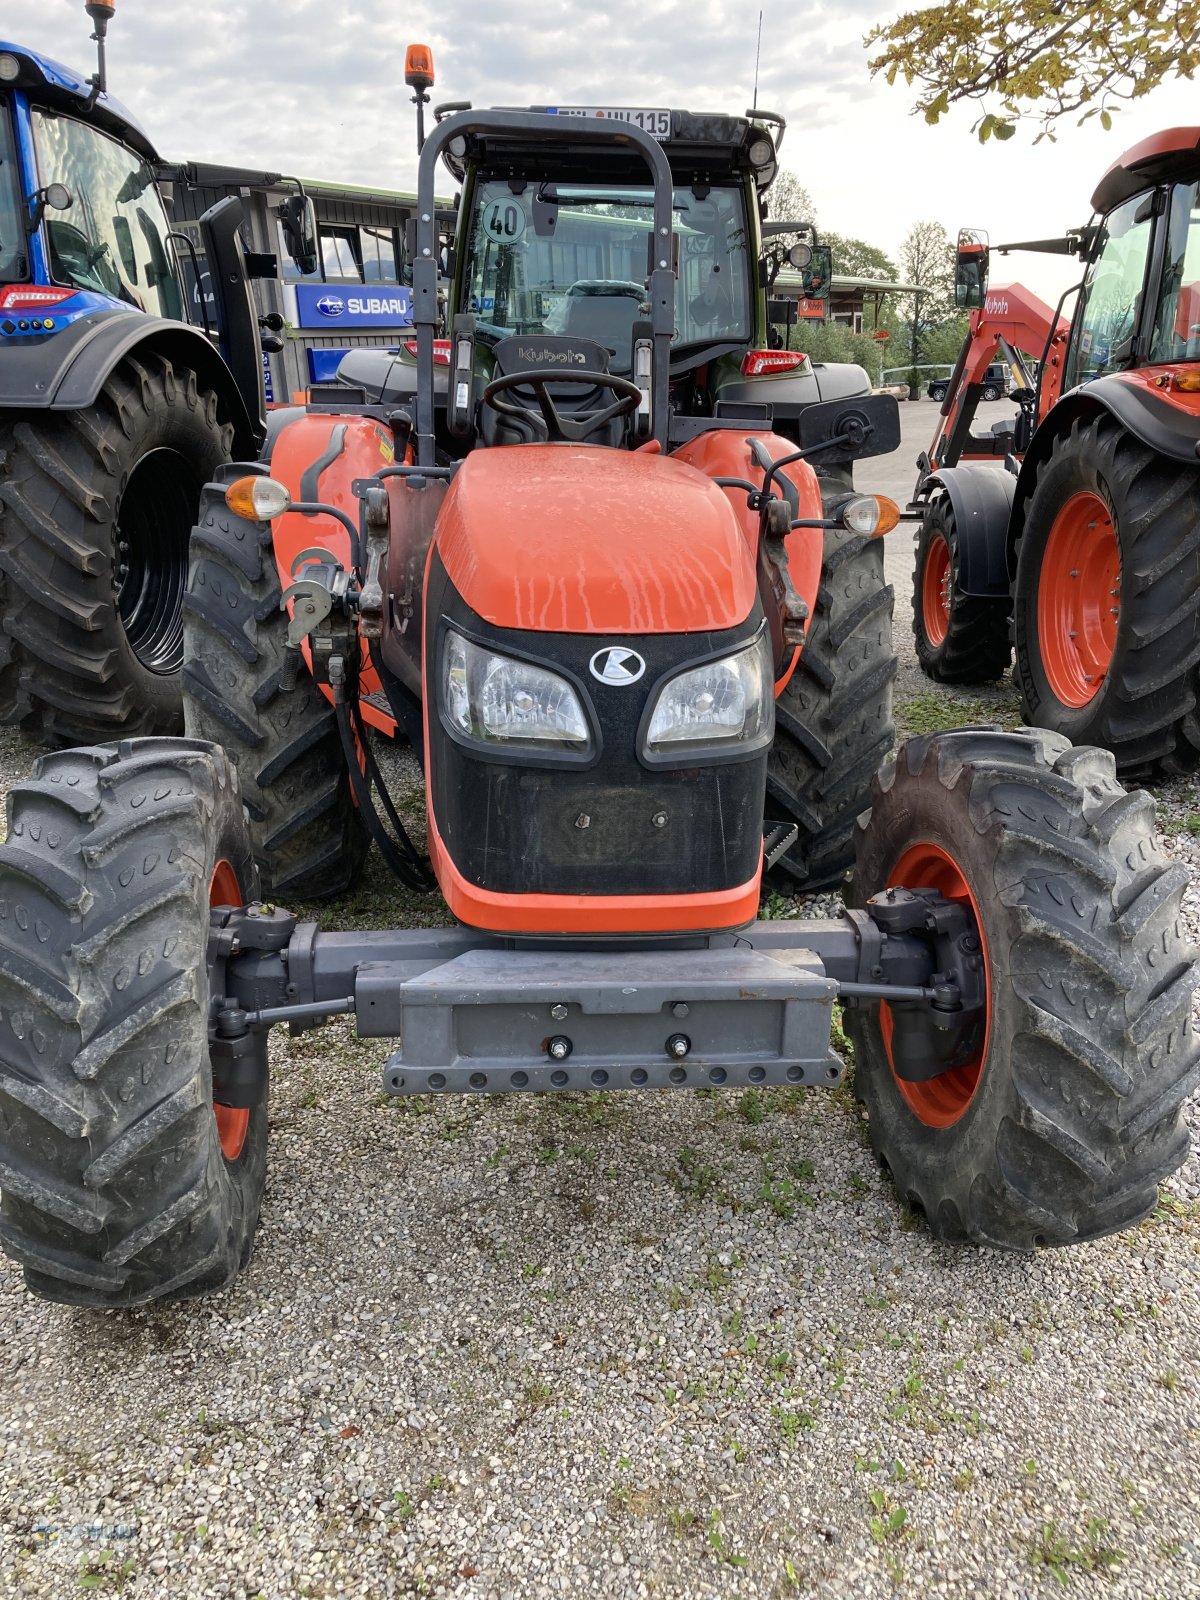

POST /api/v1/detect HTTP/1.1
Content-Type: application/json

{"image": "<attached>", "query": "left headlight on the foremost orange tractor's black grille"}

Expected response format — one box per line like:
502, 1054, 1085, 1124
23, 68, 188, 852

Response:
442, 629, 590, 752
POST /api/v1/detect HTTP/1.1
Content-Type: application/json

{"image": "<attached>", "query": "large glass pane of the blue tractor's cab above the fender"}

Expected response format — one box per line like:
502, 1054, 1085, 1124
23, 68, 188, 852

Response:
34, 110, 182, 318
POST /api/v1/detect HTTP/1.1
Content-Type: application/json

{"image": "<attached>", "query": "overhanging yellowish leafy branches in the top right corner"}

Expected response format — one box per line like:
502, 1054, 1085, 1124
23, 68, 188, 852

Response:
866, 0, 1200, 144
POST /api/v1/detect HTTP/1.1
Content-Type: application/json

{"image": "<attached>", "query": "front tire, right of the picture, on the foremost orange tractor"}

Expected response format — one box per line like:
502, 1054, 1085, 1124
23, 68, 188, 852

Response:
846, 728, 1200, 1250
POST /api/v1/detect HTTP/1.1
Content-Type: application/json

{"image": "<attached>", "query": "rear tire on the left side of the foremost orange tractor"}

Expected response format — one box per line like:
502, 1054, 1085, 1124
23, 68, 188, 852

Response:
182, 485, 370, 902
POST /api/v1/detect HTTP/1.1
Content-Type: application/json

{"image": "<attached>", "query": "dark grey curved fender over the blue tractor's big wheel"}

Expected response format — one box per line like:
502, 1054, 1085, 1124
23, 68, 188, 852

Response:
0, 307, 259, 458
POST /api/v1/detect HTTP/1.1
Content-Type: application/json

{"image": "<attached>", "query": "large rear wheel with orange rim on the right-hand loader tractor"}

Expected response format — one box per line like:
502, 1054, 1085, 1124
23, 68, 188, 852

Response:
1013, 414, 1200, 776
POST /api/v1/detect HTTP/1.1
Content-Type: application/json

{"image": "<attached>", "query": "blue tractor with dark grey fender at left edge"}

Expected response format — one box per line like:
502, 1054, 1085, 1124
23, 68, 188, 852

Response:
0, 0, 275, 744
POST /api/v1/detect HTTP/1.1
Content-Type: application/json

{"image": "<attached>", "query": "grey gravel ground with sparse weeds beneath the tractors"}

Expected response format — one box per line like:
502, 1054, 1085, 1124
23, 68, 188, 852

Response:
0, 406, 1200, 1600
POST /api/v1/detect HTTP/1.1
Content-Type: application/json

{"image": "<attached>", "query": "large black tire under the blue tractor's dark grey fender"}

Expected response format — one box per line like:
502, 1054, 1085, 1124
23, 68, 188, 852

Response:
0, 352, 234, 744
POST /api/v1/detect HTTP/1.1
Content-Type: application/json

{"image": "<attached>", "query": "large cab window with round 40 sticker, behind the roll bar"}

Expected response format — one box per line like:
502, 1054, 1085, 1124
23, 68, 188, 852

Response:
462, 179, 752, 373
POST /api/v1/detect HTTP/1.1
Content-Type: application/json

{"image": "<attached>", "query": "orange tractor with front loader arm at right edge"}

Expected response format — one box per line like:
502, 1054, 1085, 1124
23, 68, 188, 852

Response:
914, 128, 1200, 774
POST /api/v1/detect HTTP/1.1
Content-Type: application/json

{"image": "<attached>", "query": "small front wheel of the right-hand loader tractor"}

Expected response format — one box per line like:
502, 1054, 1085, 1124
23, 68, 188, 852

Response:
912, 494, 1013, 683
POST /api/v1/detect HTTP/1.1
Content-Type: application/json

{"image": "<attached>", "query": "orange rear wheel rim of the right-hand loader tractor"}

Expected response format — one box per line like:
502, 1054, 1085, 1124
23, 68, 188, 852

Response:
1037, 490, 1122, 710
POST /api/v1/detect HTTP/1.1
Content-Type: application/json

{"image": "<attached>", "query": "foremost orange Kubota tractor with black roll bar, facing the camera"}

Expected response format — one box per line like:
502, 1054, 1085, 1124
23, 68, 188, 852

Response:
0, 68, 1200, 1306
